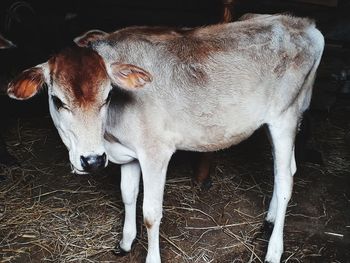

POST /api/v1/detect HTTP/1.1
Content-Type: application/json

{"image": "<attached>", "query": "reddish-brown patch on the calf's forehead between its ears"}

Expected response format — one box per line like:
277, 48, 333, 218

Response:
49, 47, 107, 106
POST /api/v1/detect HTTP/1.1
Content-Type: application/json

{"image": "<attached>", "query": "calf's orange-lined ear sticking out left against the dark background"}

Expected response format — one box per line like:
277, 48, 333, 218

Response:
7, 63, 47, 100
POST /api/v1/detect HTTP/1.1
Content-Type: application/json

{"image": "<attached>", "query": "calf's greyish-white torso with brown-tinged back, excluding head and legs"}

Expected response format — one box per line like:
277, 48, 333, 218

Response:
92, 15, 324, 151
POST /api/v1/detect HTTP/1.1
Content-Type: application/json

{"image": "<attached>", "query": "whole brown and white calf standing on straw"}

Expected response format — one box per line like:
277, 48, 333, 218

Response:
8, 15, 324, 262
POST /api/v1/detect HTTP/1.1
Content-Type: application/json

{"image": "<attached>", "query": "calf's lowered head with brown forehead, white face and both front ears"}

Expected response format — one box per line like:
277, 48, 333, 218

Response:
8, 47, 152, 173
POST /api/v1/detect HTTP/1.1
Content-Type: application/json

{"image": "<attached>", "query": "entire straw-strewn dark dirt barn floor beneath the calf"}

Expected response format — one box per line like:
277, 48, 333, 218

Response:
0, 48, 350, 263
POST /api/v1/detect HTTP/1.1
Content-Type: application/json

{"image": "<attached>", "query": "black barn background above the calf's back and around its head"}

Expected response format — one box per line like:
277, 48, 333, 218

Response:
0, 0, 350, 117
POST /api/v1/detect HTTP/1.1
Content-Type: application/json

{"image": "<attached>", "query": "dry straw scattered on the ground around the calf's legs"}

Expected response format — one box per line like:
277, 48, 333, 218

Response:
0, 99, 350, 263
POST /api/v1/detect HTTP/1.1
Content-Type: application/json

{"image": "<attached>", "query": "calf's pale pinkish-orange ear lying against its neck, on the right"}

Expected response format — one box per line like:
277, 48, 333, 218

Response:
109, 63, 153, 90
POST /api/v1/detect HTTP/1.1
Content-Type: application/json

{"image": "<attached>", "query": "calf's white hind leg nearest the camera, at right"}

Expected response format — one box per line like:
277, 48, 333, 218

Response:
265, 113, 298, 263
